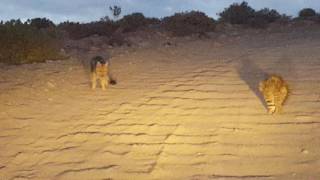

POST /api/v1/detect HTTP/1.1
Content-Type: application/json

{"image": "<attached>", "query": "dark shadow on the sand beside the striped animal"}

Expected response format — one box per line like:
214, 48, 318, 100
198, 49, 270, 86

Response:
237, 56, 268, 108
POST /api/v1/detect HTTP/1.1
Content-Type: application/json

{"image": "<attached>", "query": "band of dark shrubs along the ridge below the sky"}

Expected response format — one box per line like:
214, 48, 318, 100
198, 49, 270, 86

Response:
0, 2, 320, 64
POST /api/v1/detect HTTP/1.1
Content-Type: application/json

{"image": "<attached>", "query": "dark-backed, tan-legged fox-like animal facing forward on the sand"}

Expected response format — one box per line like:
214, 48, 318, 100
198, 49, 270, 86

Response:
90, 56, 117, 90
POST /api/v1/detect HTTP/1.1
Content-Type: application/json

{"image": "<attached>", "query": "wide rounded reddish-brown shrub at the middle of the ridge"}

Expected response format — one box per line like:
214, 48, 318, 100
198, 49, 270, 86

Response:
162, 11, 215, 36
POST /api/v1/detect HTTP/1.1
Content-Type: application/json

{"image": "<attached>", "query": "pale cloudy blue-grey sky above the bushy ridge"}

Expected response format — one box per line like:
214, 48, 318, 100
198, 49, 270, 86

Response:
0, 0, 320, 23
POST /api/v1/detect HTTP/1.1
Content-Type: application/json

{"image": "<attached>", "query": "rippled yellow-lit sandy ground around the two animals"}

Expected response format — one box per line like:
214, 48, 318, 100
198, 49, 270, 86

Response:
0, 27, 320, 180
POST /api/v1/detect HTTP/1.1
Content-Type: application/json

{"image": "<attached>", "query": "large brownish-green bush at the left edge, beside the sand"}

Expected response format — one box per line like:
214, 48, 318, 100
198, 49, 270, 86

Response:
0, 20, 62, 64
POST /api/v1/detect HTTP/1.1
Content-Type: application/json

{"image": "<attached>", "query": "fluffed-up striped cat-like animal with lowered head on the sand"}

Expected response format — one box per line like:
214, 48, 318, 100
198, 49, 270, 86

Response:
259, 75, 289, 114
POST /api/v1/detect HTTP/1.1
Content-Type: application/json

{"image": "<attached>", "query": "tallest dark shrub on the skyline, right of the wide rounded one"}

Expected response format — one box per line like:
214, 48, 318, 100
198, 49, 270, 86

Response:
219, 1, 255, 24
